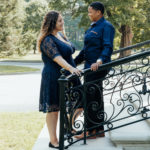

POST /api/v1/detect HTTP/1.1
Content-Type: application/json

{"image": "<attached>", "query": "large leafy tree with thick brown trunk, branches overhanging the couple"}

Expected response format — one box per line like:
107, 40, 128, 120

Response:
49, 0, 150, 57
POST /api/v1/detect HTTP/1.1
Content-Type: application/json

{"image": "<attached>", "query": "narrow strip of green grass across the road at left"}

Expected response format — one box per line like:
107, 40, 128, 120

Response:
0, 65, 40, 74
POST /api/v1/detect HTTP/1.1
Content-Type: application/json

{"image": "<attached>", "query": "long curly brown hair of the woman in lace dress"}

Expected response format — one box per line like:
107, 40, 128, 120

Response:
37, 11, 60, 52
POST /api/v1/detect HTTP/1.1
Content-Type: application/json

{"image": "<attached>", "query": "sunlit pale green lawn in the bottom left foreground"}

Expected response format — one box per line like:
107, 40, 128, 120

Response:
0, 112, 45, 150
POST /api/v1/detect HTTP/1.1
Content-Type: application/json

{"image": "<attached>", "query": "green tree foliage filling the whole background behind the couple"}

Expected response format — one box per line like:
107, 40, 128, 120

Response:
0, 0, 150, 57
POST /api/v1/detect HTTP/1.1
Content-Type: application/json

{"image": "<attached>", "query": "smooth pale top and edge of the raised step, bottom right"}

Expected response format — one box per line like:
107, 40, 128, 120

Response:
109, 121, 150, 144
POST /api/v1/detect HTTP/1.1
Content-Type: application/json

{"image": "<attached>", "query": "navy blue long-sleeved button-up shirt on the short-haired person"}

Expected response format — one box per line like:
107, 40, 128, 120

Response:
75, 17, 115, 69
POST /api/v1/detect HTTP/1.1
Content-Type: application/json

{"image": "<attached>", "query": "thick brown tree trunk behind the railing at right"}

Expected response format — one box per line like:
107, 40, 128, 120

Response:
119, 25, 133, 58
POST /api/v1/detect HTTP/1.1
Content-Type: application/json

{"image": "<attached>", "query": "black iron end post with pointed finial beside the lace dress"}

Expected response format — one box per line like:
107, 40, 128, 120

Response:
58, 72, 68, 150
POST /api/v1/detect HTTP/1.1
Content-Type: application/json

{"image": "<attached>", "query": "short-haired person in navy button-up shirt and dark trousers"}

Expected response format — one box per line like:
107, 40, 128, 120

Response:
75, 2, 115, 138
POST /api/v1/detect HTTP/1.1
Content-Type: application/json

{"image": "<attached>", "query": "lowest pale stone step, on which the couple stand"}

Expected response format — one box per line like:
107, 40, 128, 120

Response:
32, 125, 122, 150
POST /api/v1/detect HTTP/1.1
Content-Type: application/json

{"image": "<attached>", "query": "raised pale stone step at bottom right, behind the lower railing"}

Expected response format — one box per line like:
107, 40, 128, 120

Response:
109, 116, 150, 150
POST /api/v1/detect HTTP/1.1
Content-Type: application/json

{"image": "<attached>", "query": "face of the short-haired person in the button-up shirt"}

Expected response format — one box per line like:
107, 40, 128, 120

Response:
88, 6, 103, 22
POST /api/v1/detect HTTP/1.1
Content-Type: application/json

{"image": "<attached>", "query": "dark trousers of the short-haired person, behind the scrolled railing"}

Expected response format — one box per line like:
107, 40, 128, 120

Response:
84, 70, 108, 131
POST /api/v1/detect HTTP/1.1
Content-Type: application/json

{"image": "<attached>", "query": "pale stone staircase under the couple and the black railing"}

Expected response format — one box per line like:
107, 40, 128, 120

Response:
32, 113, 150, 150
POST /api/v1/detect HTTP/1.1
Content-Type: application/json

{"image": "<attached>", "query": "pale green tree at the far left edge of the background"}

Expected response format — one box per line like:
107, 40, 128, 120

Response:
0, 0, 22, 57
